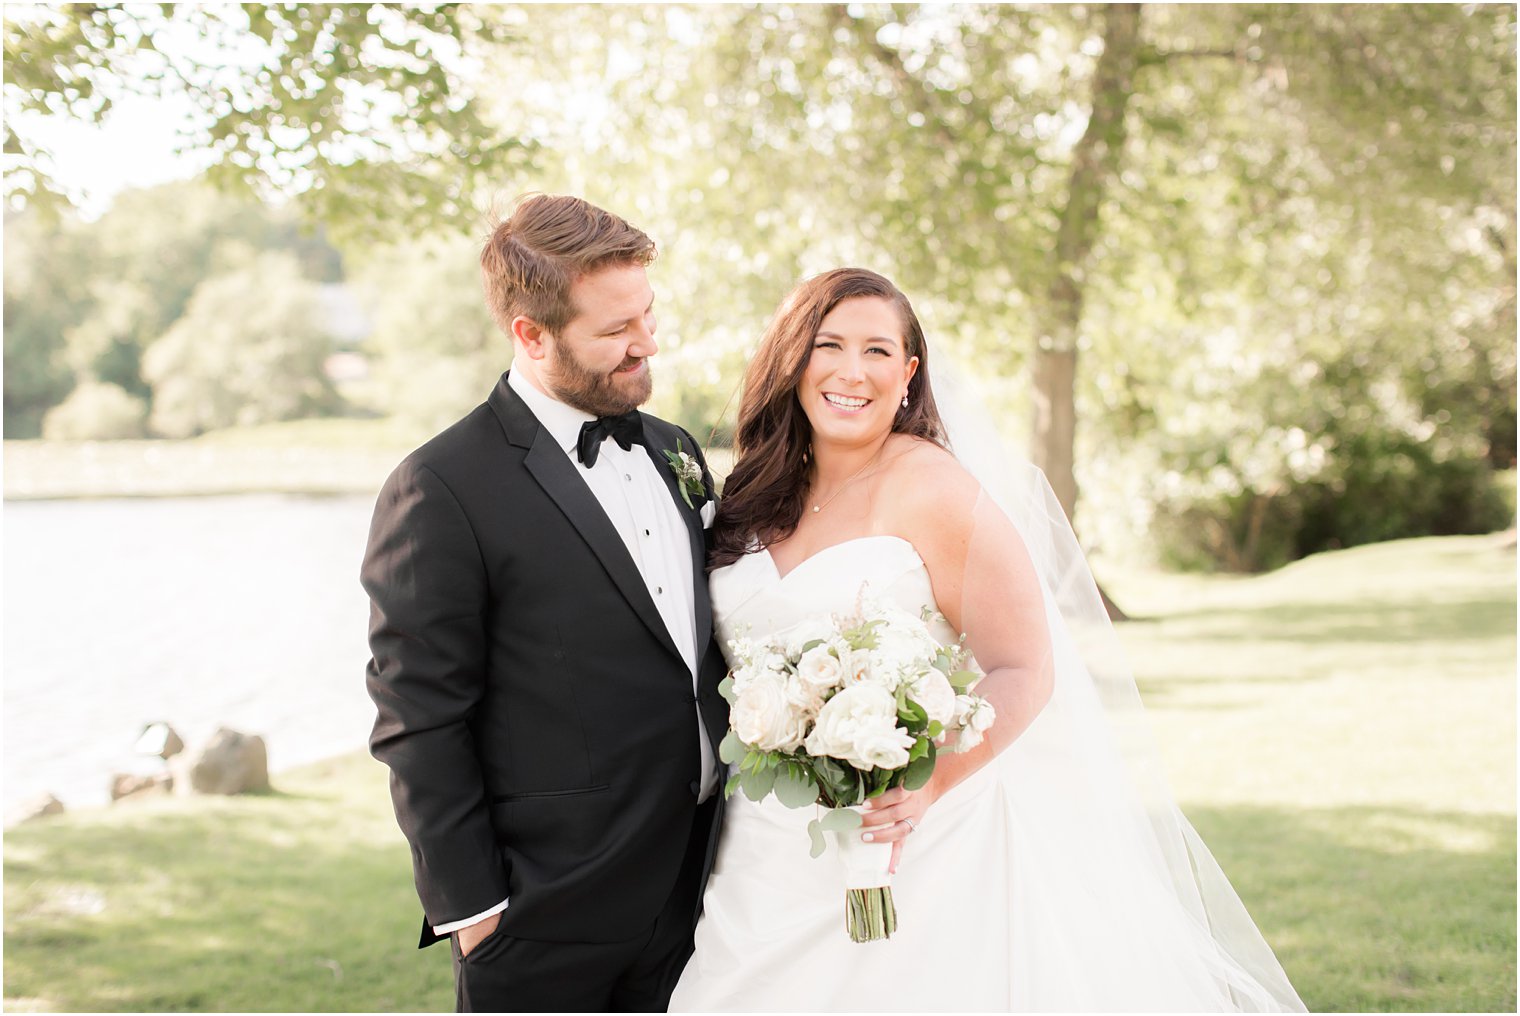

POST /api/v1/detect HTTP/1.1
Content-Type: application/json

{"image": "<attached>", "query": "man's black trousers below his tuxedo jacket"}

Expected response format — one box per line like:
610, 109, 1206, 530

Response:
451, 797, 717, 1013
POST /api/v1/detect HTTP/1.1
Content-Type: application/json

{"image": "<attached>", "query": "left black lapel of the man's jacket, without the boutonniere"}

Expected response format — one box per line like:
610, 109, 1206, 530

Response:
489, 376, 687, 663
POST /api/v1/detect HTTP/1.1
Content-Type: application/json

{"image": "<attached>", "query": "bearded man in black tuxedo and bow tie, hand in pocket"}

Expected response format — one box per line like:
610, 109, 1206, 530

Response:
362, 195, 727, 1011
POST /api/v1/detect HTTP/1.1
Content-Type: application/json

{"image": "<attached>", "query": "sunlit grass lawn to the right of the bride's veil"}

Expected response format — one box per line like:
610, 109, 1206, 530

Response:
1105, 537, 1515, 1011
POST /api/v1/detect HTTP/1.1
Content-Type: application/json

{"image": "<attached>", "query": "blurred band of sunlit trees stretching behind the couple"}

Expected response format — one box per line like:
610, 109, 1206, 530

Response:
5, 5, 1515, 570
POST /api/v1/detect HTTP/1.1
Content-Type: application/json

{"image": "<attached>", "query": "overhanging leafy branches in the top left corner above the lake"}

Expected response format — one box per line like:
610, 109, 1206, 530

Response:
5, 3, 523, 231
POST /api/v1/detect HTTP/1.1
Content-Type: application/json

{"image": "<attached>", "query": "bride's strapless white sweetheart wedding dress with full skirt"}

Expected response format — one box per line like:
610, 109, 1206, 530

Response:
670, 535, 1301, 1011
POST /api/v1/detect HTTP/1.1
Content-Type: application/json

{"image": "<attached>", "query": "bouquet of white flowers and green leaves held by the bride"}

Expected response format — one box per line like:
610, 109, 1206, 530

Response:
717, 590, 994, 941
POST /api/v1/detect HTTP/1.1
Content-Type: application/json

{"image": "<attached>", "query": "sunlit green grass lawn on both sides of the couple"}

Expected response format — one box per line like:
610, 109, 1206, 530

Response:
5, 537, 1515, 1011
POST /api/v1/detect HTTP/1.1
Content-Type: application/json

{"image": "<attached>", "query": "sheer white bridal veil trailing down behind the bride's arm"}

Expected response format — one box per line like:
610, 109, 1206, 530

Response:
930, 359, 1304, 1013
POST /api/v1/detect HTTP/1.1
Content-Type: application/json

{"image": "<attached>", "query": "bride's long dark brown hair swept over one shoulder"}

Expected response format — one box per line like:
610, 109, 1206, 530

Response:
708, 268, 945, 567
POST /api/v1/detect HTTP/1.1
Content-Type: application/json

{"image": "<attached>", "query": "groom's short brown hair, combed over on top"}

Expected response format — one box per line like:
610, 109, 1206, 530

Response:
480, 195, 655, 336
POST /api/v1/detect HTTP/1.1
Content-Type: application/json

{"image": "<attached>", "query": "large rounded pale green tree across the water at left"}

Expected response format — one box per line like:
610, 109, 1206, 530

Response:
143, 251, 336, 438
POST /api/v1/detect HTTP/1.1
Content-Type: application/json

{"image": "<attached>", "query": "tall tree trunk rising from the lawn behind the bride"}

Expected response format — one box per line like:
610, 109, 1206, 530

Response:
1032, 3, 1140, 619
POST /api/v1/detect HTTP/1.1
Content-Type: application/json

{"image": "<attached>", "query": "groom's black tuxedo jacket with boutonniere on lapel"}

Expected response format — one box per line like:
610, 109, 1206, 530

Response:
362, 374, 727, 945
